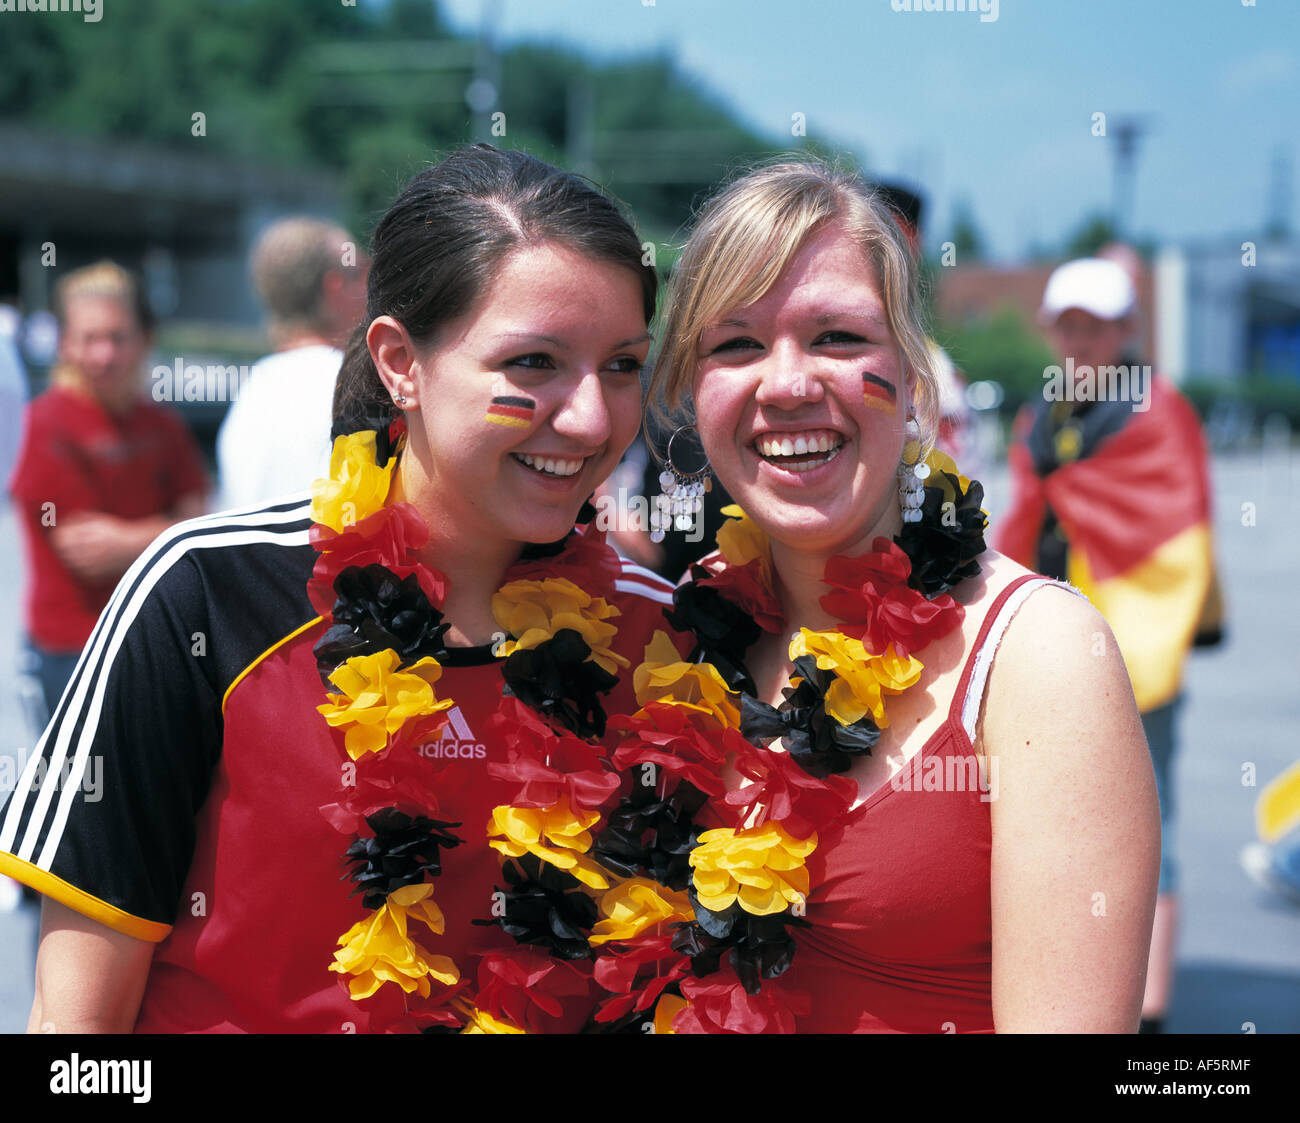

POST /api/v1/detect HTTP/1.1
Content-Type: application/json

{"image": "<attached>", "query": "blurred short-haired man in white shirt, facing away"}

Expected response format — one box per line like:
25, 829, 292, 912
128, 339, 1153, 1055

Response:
217, 218, 367, 507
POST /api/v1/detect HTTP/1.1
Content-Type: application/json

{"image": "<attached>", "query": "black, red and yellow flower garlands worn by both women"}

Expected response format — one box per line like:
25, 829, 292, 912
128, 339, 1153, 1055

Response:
308, 421, 984, 1033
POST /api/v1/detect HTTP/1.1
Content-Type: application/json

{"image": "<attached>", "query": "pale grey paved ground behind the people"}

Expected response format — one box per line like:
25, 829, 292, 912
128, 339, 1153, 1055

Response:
0, 452, 1300, 1033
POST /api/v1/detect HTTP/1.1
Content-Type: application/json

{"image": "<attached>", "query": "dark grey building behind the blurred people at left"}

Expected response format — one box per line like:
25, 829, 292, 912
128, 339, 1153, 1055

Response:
0, 123, 342, 447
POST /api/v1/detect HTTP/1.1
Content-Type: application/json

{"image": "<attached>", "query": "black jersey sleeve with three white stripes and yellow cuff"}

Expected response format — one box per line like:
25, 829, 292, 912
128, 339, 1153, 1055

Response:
0, 499, 309, 941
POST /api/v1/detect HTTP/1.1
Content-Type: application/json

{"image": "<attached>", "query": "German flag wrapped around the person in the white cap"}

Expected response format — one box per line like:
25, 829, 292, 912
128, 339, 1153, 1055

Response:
995, 376, 1217, 712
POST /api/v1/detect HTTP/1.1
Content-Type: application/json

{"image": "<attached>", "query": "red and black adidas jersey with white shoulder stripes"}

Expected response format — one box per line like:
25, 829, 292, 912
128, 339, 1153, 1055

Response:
0, 500, 677, 1033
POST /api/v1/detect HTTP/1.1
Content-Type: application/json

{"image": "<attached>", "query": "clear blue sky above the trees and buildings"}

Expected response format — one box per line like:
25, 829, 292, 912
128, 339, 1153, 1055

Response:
441, 0, 1300, 260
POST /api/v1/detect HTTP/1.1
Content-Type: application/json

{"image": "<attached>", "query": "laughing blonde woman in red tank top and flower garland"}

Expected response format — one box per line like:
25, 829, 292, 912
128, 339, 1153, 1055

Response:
651, 161, 1160, 1033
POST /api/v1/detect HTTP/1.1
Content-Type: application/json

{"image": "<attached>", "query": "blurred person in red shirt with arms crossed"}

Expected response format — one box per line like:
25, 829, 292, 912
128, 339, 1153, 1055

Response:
10, 261, 208, 716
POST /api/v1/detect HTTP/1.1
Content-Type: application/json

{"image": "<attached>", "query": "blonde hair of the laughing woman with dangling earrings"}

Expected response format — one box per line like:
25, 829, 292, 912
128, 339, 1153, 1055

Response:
649, 157, 939, 451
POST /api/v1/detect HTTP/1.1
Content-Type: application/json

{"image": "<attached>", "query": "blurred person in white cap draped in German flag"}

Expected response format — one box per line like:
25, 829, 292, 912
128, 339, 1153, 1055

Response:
996, 259, 1221, 1032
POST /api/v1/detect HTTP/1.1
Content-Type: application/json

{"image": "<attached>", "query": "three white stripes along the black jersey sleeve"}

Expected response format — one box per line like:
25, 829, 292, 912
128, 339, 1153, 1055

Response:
0, 502, 311, 871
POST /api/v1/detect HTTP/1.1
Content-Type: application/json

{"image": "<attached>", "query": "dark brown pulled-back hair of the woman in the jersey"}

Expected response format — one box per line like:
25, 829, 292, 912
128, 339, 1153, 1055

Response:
332, 144, 658, 437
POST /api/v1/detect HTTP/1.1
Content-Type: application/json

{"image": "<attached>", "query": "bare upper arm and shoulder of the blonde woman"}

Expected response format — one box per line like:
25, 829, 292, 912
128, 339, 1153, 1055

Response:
978, 553, 1160, 1033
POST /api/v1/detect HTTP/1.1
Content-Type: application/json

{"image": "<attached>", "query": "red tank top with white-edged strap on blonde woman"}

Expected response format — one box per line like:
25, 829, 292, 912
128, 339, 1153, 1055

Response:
781, 574, 1069, 1033
